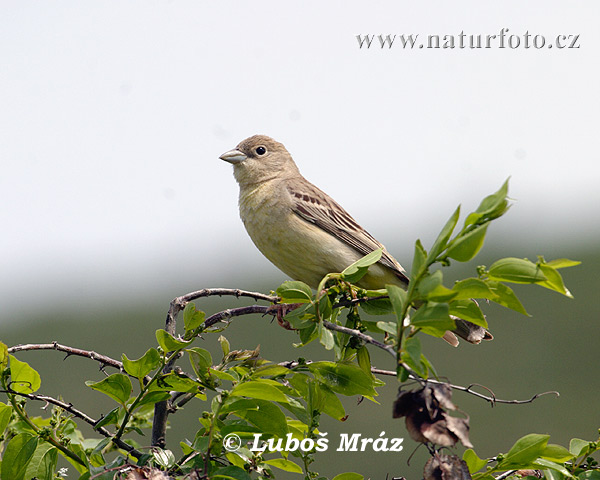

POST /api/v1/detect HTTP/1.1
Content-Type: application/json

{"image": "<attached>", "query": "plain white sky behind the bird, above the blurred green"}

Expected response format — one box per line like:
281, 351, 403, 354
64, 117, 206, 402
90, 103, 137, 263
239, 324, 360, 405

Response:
0, 0, 600, 322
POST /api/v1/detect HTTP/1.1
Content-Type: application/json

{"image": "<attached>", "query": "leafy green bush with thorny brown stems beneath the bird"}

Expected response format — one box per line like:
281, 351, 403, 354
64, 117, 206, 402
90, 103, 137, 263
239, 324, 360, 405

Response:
0, 181, 600, 480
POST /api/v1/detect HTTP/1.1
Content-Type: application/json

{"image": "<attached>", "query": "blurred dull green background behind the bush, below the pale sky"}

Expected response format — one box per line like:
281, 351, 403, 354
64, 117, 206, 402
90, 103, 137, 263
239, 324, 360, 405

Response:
2, 234, 600, 479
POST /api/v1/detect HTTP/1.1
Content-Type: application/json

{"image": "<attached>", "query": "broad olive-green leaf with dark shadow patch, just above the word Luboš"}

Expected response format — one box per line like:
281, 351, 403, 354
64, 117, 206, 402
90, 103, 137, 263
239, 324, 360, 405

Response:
308, 362, 377, 396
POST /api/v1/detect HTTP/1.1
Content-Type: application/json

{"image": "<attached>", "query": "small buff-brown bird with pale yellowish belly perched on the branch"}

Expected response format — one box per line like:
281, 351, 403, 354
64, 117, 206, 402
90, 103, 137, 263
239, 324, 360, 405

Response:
219, 135, 493, 346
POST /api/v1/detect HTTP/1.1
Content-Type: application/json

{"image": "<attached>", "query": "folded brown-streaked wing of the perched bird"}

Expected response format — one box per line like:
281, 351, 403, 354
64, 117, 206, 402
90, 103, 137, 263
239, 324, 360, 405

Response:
287, 179, 408, 284
